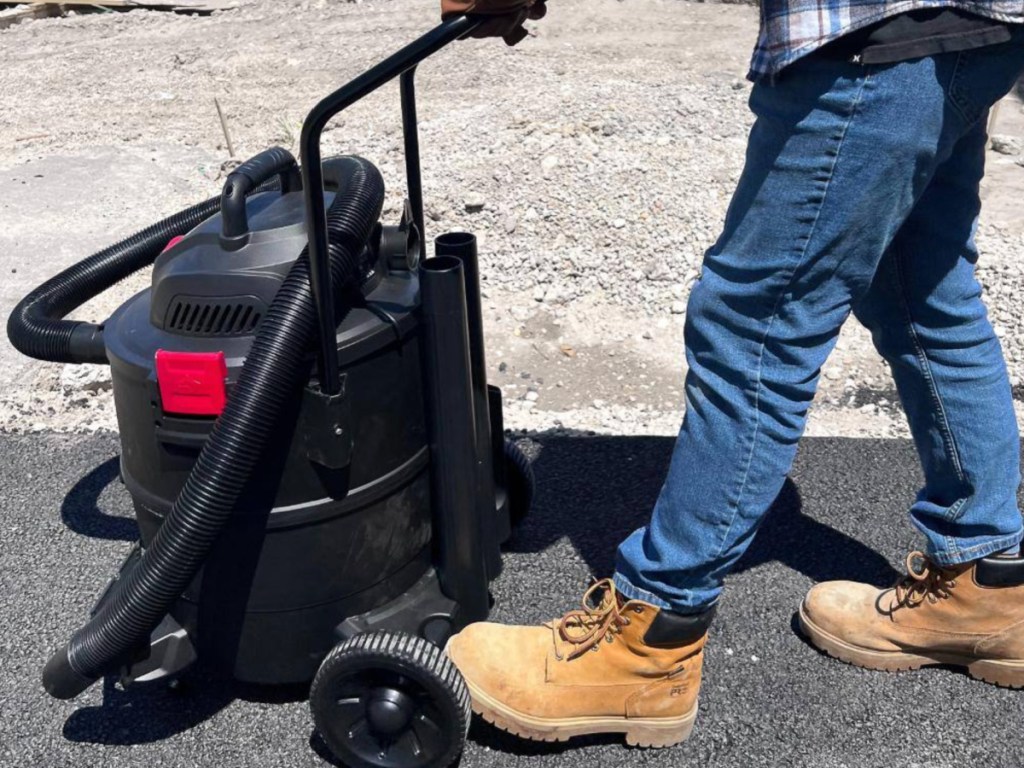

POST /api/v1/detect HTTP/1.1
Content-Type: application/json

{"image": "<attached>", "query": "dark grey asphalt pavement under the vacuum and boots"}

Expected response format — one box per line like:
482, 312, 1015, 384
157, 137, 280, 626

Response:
0, 434, 1024, 768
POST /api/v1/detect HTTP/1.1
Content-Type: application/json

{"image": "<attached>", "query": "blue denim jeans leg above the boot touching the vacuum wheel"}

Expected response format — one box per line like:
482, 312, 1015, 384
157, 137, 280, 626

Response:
615, 40, 1021, 612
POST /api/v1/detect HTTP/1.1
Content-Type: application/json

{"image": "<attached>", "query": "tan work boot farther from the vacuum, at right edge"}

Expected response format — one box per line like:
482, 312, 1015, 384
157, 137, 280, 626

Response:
800, 552, 1024, 688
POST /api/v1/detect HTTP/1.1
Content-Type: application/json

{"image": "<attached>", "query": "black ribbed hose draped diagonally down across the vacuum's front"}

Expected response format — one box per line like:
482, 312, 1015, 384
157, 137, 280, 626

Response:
40, 158, 384, 698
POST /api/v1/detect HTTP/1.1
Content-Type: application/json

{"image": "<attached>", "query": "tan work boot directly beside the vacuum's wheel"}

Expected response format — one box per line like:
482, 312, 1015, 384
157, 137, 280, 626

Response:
447, 581, 714, 746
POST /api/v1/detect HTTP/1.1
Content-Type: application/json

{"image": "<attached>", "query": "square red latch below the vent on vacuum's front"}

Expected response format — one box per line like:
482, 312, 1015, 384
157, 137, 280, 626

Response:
157, 349, 227, 416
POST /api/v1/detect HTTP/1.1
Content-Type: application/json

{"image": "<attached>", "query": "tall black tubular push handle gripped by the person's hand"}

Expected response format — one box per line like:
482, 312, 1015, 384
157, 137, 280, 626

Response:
300, 16, 480, 395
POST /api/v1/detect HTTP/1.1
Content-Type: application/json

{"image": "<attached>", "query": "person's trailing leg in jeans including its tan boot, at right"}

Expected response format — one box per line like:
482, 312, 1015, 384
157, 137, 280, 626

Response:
799, 31, 1024, 687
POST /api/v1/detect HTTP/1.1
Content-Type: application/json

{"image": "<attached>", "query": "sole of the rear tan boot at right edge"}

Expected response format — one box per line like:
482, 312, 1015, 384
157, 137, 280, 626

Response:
800, 605, 1024, 688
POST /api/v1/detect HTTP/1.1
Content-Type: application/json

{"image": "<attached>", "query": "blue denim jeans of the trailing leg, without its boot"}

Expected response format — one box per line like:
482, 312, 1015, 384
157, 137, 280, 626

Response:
854, 119, 1022, 565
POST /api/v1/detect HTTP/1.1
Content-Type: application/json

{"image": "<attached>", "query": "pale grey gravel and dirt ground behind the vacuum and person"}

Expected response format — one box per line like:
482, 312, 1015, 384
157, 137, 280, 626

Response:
0, 0, 1024, 435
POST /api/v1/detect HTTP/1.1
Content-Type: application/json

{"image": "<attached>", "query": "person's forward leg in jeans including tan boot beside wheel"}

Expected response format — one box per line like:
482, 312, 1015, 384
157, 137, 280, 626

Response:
449, 34, 1024, 745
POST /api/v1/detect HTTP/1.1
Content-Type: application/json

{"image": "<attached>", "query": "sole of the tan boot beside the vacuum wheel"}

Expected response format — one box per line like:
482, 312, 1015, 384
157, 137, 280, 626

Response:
466, 680, 697, 750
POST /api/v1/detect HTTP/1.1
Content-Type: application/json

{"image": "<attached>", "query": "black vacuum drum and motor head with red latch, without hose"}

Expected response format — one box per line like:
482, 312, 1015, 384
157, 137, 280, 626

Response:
103, 186, 440, 683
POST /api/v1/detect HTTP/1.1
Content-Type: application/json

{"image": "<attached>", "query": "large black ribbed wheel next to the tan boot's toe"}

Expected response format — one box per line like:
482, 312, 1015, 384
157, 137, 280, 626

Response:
309, 632, 472, 768
